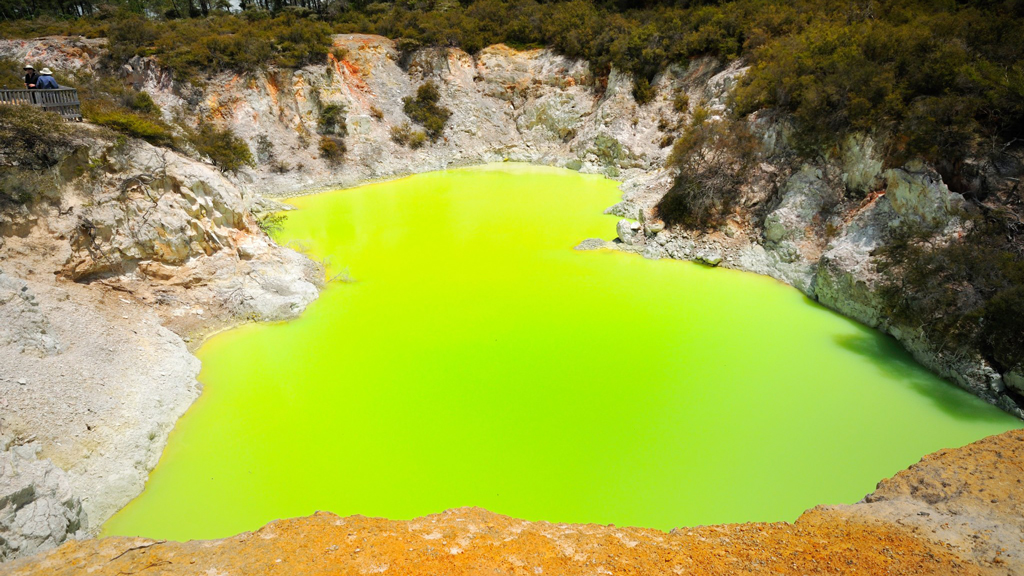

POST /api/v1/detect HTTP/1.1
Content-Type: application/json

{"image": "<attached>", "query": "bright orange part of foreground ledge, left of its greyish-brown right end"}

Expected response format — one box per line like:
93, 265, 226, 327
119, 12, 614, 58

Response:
0, 508, 986, 576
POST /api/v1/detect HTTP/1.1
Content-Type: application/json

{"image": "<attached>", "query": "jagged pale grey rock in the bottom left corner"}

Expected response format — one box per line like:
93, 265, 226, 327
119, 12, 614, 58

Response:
0, 445, 85, 562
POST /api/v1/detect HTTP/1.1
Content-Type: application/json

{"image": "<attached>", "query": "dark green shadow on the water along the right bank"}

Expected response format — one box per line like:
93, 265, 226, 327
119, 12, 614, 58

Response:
834, 323, 1011, 421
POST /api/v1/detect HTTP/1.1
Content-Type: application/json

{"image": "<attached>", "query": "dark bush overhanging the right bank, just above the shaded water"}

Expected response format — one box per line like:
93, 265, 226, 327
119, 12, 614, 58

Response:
874, 214, 1024, 371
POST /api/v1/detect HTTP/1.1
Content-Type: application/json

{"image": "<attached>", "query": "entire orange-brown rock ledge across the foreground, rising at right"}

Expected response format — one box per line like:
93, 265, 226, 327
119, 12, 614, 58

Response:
8, 430, 1024, 576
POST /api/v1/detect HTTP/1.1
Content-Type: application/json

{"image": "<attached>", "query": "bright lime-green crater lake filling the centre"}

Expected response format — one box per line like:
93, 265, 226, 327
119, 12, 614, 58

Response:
104, 165, 1020, 539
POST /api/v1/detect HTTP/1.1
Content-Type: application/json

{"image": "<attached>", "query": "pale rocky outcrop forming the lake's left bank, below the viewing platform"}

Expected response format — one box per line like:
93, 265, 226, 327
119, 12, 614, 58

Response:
0, 121, 324, 559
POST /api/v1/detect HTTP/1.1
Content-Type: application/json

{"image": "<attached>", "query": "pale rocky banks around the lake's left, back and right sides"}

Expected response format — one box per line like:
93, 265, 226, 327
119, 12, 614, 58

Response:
0, 35, 1024, 560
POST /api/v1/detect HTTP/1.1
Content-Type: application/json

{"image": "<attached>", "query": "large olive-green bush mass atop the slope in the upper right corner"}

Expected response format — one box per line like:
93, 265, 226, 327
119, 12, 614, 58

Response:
736, 8, 1024, 175
